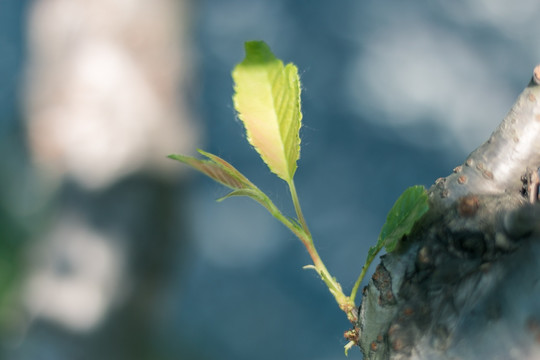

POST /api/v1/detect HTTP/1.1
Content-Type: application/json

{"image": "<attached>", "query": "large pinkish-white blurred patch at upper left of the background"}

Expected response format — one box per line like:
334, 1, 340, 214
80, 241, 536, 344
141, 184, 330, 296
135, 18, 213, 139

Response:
26, 0, 197, 189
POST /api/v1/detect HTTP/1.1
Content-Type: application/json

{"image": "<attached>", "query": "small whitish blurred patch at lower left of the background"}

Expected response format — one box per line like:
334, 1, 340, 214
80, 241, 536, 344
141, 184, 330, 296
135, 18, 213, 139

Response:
24, 216, 126, 331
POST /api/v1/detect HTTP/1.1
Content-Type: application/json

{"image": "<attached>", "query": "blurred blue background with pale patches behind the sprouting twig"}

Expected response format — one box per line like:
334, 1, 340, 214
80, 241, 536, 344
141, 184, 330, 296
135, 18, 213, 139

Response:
0, 0, 540, 360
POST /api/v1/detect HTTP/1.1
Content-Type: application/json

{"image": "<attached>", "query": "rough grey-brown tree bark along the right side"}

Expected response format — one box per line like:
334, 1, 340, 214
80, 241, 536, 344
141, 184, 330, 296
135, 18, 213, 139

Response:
358, 65, 540, 359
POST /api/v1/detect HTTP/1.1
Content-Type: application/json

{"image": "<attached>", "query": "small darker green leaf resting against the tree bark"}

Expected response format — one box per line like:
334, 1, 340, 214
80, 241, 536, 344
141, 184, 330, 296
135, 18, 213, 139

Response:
377, 185, 429, 252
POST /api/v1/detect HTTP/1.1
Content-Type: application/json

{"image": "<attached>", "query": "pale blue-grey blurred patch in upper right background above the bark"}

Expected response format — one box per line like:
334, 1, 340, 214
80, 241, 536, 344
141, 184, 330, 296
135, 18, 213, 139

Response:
348, 18, 516, 149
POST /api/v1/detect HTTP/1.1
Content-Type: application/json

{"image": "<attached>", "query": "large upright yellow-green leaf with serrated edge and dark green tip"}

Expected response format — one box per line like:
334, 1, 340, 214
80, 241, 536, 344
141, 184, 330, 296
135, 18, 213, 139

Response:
232, 41, 302, 182
